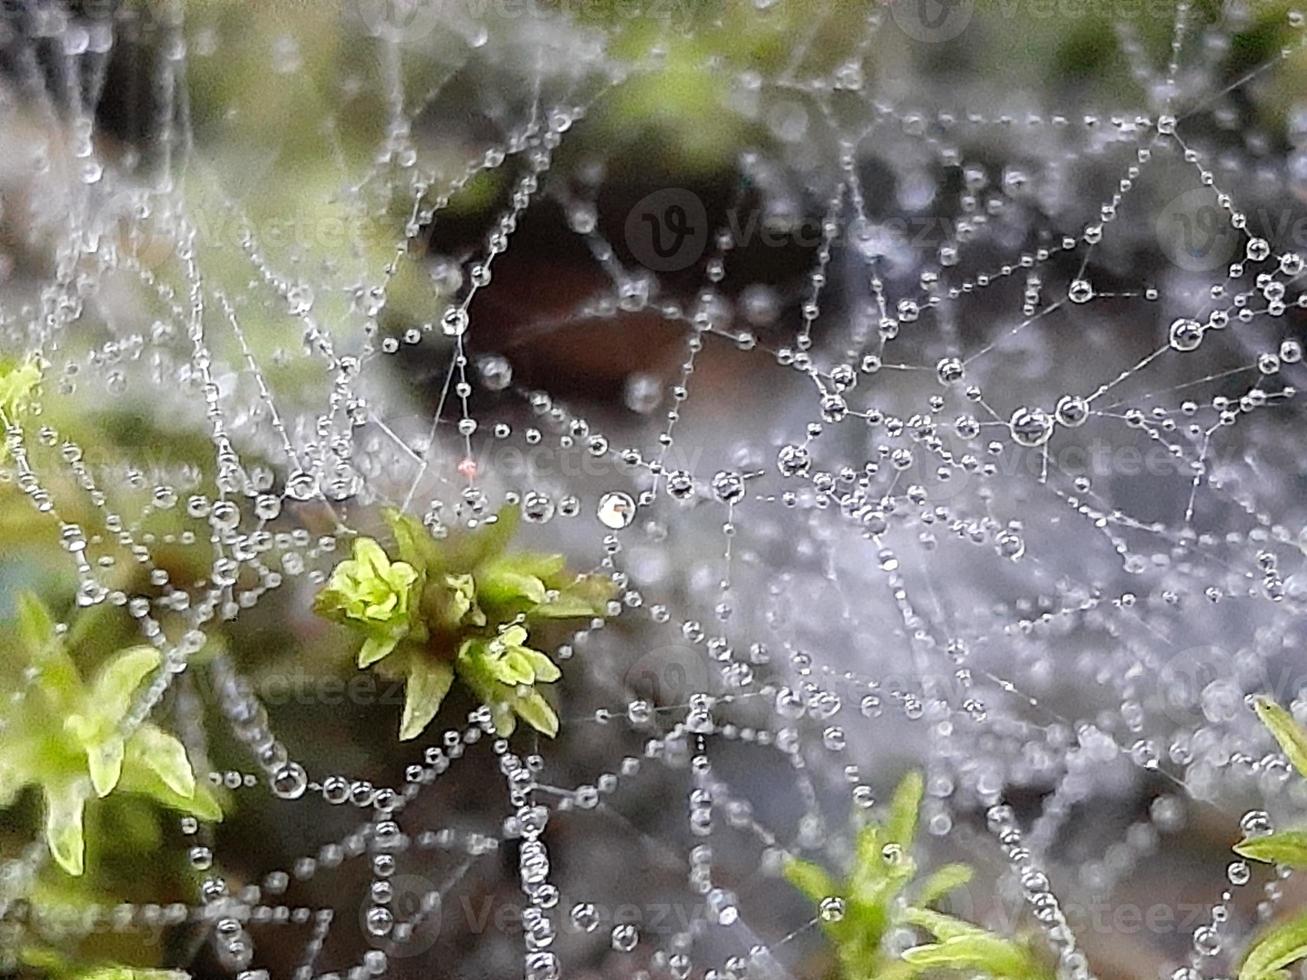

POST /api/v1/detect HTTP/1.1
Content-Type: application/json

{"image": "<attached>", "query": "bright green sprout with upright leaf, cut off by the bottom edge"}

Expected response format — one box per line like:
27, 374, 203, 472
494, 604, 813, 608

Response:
784, 771, 1053, 980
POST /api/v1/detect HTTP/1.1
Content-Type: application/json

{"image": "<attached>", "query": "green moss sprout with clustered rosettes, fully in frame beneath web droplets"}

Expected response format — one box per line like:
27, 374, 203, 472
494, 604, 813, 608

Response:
314, 507, 612, 740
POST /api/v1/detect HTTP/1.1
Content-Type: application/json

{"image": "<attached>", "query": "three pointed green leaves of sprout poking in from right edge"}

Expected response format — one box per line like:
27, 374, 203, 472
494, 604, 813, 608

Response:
1234, 696, 1307, 980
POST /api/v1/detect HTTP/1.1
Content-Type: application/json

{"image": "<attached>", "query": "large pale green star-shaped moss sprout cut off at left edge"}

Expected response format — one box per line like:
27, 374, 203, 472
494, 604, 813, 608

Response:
0, 595, 222, 875
